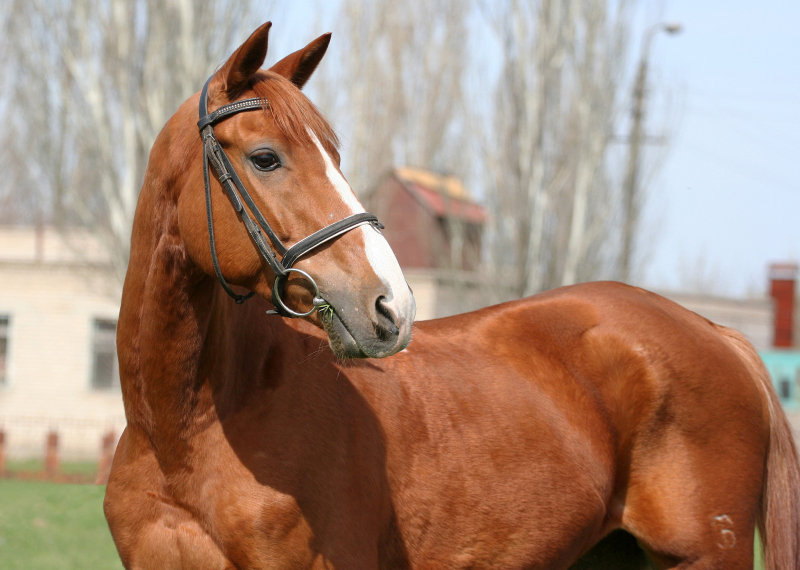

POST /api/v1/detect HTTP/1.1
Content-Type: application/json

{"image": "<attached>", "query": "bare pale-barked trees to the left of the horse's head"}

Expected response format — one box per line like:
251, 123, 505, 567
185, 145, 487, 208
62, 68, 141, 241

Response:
2, 0, 272, 275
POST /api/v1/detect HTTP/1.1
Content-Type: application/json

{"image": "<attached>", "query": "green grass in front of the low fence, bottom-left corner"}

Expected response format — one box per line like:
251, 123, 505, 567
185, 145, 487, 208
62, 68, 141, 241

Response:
0, 480, 122, 570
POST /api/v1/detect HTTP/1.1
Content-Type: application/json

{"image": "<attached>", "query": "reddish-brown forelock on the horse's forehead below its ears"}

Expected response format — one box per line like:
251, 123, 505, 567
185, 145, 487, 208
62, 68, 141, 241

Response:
252, 71, 339, 154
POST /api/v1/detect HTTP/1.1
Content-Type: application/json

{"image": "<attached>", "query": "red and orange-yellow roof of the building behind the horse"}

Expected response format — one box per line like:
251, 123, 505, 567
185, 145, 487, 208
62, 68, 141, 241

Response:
395, 167, 487, 224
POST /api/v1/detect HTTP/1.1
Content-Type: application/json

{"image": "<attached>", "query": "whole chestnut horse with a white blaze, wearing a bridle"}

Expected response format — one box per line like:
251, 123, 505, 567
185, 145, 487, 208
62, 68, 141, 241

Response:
105, 24, 800, 570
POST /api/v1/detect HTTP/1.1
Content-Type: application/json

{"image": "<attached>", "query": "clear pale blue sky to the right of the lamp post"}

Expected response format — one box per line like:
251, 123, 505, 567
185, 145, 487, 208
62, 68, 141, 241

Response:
643, 0, 800, 297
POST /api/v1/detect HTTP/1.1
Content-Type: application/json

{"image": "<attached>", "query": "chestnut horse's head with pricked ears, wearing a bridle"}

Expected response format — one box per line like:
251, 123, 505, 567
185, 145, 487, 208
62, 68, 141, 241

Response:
171, 23, 415, 357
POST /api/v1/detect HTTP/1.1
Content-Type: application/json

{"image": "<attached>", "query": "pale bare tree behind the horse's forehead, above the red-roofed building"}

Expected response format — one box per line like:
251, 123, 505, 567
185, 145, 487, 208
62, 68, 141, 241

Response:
316, 0, 470, 199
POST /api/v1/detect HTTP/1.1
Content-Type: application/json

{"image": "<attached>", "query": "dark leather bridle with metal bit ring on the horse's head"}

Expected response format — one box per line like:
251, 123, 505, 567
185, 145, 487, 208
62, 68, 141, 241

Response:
197, 76, 383, 317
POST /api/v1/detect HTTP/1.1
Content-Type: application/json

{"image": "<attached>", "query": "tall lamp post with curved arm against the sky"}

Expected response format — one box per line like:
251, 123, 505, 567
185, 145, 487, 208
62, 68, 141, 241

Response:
620, 23, 682, 281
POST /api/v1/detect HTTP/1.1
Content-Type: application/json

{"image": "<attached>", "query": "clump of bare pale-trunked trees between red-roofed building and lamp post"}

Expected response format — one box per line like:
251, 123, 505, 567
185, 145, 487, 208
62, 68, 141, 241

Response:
484, 0, 628, 295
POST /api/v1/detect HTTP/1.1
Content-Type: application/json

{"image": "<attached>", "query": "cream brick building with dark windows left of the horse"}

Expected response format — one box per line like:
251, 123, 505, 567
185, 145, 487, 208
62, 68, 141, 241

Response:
0, 227, 125, 459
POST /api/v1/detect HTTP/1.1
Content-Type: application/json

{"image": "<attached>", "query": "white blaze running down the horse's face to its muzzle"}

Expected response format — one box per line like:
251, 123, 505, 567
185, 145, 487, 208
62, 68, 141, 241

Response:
309, 131, 413, 314
